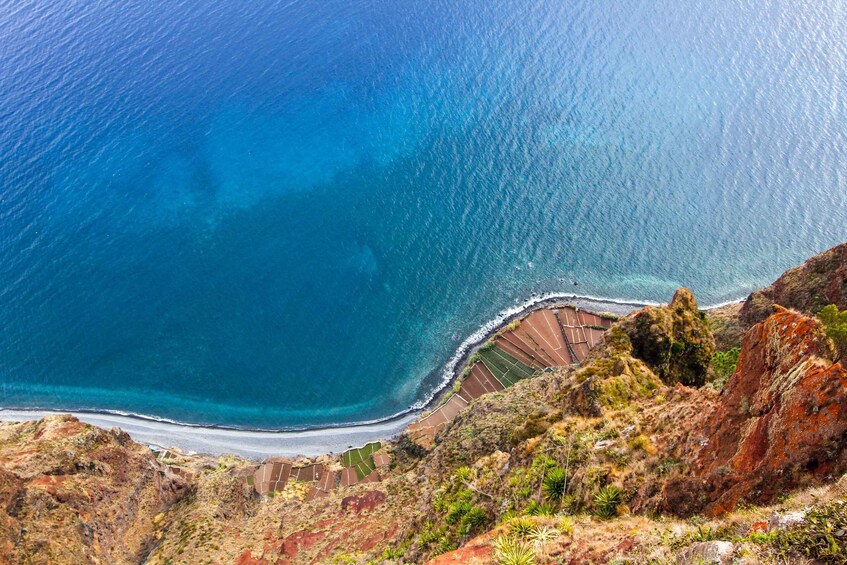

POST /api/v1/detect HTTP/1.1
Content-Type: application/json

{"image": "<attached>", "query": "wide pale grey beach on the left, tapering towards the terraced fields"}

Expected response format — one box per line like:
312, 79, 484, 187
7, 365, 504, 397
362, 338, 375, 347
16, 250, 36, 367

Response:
0, 409, 417, 460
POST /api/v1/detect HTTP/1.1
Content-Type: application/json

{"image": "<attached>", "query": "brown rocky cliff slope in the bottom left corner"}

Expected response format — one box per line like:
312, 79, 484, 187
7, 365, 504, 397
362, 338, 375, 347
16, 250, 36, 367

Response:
0, 416, 186, 564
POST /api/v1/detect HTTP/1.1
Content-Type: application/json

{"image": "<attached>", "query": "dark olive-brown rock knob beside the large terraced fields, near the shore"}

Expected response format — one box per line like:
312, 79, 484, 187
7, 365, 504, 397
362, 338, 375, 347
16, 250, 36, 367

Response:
622, 288, 715, 386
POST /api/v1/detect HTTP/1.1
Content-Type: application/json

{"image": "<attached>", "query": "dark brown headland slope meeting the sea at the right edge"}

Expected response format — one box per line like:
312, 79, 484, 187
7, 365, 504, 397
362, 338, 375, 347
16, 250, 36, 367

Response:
741, 243, 847, 328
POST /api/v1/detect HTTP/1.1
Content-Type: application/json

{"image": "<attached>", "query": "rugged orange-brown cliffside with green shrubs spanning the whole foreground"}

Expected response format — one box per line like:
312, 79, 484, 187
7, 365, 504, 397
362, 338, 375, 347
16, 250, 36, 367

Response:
0, 248, 847, 565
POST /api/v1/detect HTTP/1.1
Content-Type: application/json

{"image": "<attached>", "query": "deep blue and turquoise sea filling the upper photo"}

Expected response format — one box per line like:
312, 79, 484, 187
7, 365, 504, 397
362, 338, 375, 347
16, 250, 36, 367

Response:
0, 0, 847, 427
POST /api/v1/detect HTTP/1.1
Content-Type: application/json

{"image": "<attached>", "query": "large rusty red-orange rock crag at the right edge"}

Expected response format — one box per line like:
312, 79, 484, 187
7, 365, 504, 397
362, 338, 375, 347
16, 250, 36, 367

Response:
665, 307, 847, 515
